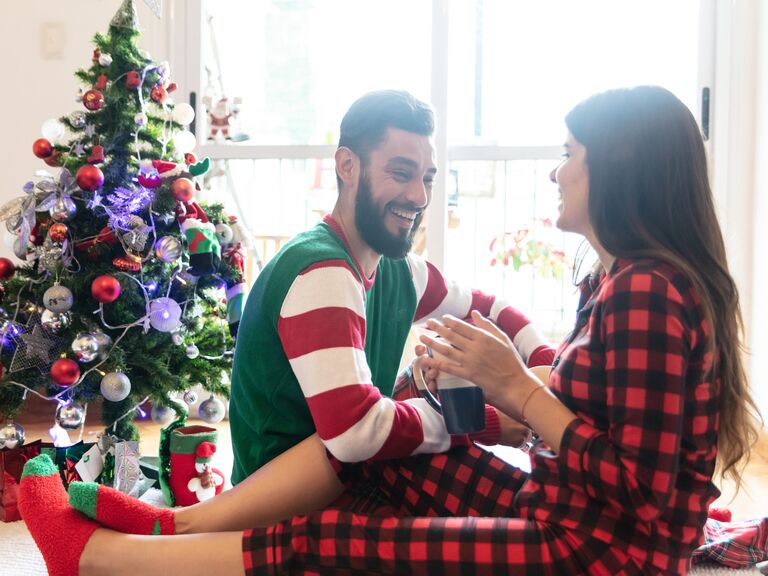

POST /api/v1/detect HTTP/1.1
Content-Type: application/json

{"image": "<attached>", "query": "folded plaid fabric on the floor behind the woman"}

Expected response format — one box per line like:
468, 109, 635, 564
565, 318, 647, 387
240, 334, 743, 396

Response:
692, 518, 768, 568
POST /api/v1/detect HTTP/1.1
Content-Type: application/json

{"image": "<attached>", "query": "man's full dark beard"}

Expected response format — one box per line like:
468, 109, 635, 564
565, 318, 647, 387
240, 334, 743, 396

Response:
355, 174, 424, 259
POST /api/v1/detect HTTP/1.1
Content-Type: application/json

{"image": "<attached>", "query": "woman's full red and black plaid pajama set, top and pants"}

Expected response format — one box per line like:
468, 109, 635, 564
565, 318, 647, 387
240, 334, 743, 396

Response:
244, 260, 720, 575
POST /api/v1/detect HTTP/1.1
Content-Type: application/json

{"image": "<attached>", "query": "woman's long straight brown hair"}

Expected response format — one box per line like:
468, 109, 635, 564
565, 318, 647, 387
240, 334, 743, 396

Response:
566, 86, 762, 485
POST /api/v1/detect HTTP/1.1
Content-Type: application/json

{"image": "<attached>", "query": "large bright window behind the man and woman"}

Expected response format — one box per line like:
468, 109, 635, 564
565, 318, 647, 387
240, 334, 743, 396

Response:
183, 0, 714, 338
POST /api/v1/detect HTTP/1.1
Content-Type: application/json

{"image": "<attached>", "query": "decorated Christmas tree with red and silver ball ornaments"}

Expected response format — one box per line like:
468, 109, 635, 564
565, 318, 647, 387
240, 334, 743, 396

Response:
0, 0, 244, 447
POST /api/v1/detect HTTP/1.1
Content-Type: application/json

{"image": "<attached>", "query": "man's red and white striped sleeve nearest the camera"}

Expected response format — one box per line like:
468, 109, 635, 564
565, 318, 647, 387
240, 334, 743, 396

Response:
278, 260, 451, 462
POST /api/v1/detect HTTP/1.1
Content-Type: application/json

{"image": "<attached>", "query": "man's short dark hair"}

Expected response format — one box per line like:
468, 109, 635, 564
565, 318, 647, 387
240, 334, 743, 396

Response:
337, 90, 435, 187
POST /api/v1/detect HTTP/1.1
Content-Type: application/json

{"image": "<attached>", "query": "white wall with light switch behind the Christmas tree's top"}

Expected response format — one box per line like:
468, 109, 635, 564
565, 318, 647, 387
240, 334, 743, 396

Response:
0, 0, 173, 256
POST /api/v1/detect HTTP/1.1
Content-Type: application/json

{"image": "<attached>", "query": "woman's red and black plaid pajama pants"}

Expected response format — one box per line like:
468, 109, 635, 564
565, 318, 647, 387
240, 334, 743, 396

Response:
243, 446, 641, 576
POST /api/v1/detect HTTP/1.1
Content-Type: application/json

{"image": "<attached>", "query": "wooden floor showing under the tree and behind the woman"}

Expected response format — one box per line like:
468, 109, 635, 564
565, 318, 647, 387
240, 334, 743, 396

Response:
19, 418, 768, 521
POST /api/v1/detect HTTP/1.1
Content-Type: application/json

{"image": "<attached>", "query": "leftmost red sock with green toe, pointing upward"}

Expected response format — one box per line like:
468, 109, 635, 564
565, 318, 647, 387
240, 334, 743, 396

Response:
19, 454, 99, 576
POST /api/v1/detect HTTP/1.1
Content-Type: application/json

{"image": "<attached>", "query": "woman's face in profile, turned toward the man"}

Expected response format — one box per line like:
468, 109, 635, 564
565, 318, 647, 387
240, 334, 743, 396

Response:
549, 132, 592, 237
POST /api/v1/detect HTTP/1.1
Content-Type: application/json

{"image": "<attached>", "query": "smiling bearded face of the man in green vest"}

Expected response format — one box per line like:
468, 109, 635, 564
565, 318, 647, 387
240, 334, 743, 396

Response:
355, 128, 437, 258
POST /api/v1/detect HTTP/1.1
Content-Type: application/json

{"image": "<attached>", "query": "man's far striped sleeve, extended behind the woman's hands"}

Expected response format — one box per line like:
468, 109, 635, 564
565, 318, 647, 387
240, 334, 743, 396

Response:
408, 254, 555, 367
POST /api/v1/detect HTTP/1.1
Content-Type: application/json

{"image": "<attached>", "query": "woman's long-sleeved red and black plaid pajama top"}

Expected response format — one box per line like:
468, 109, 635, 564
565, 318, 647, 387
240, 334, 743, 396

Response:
510, 259, 720, 574
